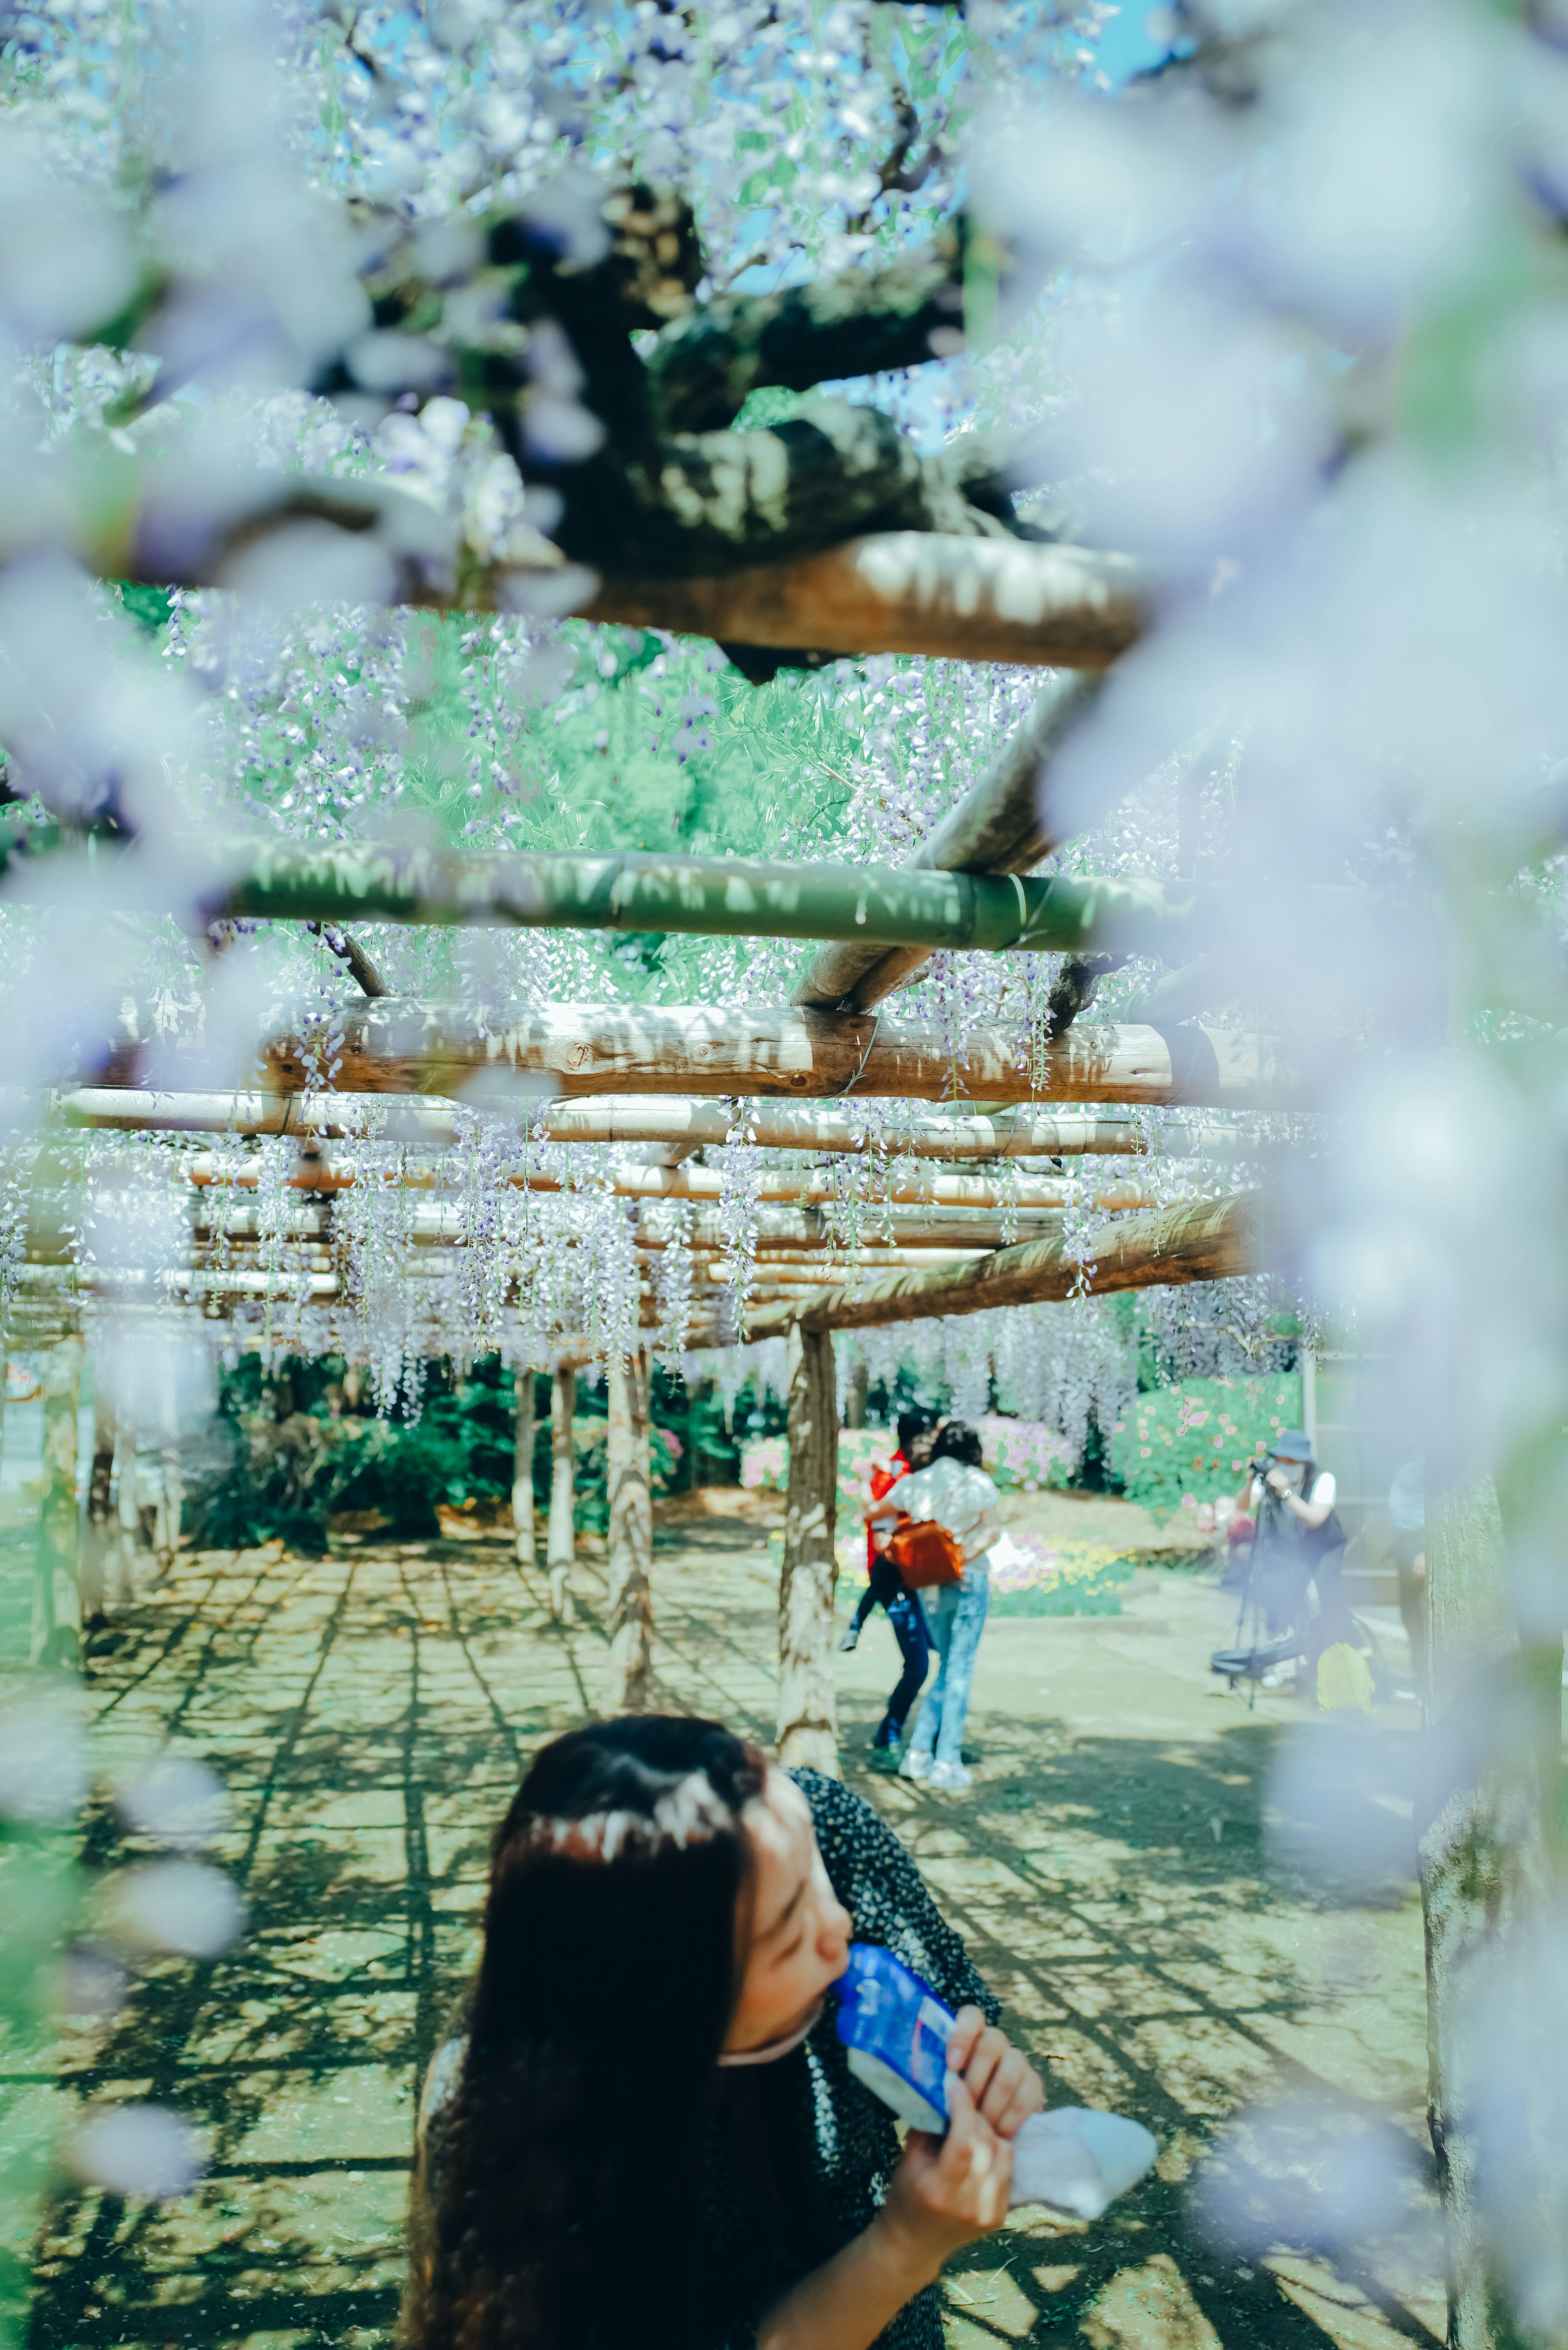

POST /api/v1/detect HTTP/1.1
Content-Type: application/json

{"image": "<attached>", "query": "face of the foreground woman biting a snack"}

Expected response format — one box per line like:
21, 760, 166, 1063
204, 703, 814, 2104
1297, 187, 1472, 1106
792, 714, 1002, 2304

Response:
724, 1770, 853, 2051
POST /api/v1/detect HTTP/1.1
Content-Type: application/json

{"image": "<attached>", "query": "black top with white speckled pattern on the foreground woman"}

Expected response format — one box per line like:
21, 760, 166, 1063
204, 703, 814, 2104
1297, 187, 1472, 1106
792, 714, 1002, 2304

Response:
414, 1770, 1002, 2350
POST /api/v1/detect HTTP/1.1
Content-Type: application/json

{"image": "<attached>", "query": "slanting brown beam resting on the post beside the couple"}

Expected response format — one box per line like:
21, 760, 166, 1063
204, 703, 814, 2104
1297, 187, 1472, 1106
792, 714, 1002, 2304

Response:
750, 1191, 1263, 1337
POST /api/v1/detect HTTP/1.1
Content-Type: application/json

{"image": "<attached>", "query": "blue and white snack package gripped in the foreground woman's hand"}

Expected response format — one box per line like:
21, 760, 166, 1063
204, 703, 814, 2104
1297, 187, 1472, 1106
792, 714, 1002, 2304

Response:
837, 1941, 1159, 2218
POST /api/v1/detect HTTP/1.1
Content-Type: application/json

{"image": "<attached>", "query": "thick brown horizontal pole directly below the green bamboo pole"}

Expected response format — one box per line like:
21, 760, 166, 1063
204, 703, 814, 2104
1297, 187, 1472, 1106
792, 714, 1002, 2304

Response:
242, 997, 1302, 1116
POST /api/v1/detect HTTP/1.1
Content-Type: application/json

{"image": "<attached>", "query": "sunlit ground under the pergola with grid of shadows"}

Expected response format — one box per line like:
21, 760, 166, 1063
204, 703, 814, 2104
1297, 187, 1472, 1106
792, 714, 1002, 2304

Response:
14, 1521, 1441, 2350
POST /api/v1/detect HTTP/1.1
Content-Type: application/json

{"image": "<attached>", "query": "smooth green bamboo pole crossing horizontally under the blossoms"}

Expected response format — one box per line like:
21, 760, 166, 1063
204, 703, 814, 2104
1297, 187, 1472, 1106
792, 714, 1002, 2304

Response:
49, 827, 1201, 961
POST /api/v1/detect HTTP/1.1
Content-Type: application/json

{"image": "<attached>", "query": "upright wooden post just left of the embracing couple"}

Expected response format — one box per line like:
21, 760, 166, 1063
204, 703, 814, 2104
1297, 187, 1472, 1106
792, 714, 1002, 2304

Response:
776, 1328, 839, 1779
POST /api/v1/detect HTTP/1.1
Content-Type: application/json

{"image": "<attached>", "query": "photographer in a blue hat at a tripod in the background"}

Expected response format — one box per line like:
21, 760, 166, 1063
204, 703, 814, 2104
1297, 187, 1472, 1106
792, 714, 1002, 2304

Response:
1215, 1429, 1345, 1687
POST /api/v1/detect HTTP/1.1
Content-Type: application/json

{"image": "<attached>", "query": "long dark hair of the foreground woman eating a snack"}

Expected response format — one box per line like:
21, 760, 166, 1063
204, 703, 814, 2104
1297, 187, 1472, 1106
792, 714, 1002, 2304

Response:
402, 1713, 766, 2350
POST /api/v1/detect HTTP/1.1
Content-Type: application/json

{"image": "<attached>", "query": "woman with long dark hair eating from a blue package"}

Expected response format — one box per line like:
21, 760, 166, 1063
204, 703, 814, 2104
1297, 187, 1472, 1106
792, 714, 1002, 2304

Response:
404, 1715, 1041, 2350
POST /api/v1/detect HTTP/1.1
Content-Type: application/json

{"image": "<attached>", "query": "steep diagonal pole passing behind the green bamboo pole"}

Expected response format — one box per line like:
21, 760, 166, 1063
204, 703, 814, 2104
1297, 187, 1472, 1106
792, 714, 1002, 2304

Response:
790, 672, 1100, 1013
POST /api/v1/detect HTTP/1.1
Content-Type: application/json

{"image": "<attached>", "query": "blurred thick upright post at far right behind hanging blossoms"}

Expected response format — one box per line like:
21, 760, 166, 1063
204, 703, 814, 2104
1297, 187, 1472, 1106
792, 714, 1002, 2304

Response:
1418, 1480, 1563, 2350
